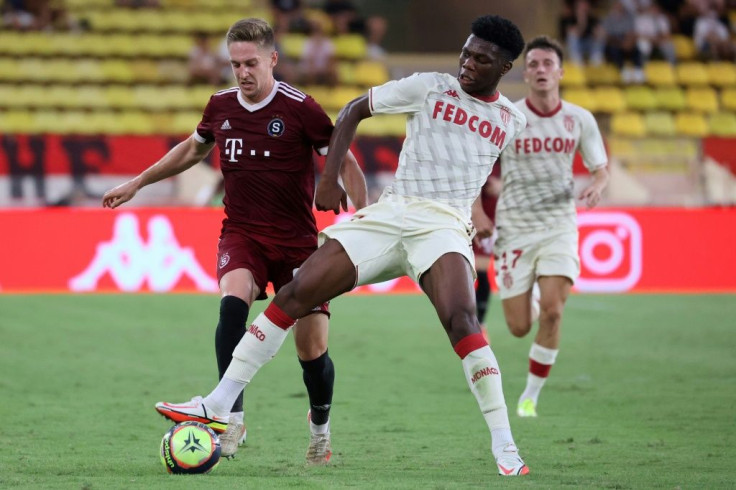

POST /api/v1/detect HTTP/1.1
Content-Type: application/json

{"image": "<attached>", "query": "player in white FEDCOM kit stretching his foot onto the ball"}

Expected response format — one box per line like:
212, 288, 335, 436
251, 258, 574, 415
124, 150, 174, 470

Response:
158, 16, 529, 475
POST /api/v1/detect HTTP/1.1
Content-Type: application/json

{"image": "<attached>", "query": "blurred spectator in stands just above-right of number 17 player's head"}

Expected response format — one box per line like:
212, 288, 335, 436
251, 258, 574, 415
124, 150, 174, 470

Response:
560, 0, 605, 65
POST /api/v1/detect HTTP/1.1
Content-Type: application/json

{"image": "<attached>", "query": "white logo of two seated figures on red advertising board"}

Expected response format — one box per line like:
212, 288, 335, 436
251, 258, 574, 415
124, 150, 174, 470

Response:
69, 213, 218, 292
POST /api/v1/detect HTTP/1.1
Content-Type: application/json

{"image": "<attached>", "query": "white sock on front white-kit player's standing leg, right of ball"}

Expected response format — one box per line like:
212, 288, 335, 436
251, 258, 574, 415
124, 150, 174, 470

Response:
462, 345, 514, 455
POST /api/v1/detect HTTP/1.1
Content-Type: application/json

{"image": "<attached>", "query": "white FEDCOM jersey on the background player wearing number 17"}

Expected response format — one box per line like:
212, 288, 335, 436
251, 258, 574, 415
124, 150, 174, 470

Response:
496, 99, 607, 236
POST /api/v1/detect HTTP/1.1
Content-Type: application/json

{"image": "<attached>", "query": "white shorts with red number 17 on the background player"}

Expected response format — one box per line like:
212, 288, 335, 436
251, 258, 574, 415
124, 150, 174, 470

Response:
493, 230, 580, 299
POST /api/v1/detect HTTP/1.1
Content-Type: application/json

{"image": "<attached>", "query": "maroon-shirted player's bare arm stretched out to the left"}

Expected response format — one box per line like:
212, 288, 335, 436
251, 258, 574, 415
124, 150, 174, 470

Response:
102, 136, 214, 208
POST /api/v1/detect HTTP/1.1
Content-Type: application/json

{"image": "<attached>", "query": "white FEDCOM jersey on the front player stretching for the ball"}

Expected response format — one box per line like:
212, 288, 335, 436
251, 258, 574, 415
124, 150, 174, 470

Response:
368, 73, 526, 219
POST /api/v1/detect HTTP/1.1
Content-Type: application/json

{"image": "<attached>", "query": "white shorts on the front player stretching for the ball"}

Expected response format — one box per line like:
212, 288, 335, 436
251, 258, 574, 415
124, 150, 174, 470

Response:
319, 195, 475, 286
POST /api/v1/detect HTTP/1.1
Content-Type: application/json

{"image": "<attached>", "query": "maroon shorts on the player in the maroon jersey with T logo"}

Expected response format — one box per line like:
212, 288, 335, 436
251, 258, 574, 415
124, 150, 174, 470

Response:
217, 231, 330, 316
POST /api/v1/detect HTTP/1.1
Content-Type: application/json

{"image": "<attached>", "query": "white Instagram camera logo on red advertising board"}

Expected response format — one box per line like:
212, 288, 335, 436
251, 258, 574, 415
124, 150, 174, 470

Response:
575, 211, 642, 293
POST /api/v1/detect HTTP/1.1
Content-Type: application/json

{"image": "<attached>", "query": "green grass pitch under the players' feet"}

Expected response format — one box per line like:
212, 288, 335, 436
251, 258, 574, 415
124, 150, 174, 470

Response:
0, 295, 736, 489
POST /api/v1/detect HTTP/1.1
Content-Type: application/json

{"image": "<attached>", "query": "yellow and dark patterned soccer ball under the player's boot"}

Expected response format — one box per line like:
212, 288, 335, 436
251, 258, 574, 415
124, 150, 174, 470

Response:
161, 422, 220, 475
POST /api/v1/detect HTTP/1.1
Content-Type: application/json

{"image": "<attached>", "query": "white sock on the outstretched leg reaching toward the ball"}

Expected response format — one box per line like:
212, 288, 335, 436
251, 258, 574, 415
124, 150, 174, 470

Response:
204, 313, 289, 414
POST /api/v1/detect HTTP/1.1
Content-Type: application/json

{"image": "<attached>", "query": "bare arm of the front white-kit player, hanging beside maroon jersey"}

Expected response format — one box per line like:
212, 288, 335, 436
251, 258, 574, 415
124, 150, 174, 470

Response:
314, 95, 371, 214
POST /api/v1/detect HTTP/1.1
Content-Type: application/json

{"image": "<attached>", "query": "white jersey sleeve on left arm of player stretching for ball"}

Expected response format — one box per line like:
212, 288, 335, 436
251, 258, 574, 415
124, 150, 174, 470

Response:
368, 73, 435, 114
